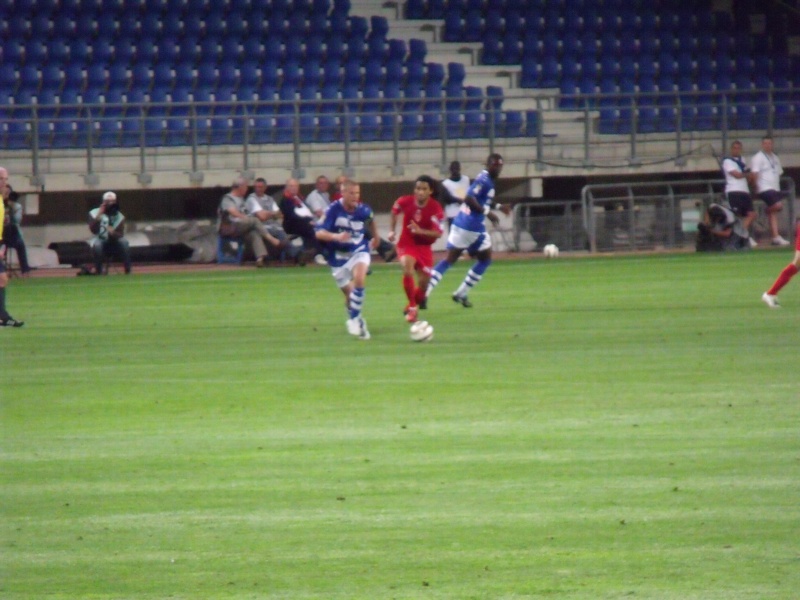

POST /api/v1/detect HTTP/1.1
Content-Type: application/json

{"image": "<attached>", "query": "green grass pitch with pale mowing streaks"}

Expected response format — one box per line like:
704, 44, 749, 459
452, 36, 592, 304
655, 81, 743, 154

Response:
0, 251, 800, 600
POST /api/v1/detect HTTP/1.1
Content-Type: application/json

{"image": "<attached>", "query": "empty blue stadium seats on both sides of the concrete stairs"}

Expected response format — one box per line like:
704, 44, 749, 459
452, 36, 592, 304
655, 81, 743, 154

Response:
0, 0, 800, 155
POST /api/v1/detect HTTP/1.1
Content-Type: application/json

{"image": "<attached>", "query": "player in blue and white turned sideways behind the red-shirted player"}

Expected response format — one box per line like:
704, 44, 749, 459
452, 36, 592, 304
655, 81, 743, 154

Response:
426, 154, 511, 308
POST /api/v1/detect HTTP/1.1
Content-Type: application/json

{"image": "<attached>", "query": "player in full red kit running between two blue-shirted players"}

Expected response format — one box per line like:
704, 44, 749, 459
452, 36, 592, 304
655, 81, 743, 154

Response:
389, 175, 444, 323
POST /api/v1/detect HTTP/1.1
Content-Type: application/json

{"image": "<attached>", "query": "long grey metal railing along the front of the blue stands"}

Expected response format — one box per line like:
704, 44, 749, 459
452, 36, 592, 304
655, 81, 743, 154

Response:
0, 88, 800, 180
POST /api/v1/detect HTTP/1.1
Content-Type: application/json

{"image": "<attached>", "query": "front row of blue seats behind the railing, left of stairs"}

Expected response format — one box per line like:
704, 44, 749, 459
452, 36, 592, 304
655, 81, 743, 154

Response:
0, 103, 536, 149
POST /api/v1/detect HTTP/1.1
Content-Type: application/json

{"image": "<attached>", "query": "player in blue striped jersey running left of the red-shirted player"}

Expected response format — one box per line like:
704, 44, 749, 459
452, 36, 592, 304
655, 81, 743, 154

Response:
316, 180, 378, 340
